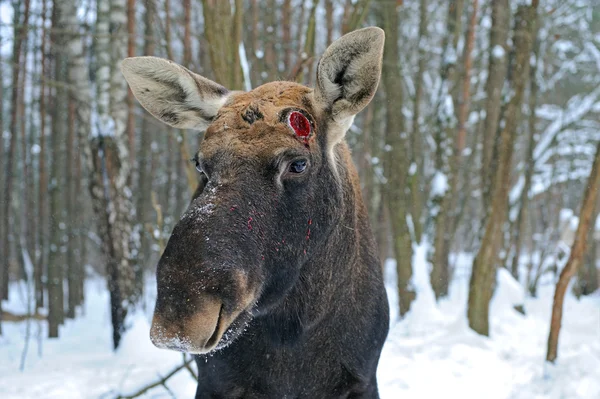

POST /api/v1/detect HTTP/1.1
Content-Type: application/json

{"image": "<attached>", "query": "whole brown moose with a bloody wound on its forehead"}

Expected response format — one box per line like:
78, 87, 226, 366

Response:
121, 27, 389, 399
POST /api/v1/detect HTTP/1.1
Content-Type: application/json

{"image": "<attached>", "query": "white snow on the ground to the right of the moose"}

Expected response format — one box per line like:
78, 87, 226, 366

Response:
378, 252, 600, 399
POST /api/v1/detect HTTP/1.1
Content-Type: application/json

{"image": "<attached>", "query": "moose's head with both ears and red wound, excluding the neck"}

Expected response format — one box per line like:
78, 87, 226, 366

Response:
122, 28, 384, 353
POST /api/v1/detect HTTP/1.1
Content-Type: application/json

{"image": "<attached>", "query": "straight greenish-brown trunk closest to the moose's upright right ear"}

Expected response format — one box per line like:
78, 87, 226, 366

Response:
381, 2, 416, 316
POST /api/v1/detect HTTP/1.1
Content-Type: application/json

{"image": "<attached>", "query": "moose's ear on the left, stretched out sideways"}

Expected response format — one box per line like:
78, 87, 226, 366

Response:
121, 57, 229, 130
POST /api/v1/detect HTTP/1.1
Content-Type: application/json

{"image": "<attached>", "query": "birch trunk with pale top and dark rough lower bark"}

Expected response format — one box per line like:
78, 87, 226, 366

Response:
91, 0, 137, 349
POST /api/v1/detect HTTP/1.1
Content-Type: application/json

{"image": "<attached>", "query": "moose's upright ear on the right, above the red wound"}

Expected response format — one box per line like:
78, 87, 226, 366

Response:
315, 27, 385, 144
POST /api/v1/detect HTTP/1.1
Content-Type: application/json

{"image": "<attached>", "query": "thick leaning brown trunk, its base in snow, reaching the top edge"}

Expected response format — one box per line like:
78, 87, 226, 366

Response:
467, 4, 537, 335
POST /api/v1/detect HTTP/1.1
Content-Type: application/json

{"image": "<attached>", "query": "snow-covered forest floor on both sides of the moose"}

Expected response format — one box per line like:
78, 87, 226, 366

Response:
0, 248, 600, 399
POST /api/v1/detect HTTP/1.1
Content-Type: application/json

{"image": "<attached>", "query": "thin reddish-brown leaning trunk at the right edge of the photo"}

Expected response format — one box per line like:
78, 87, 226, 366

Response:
546, 143, 600, 363
